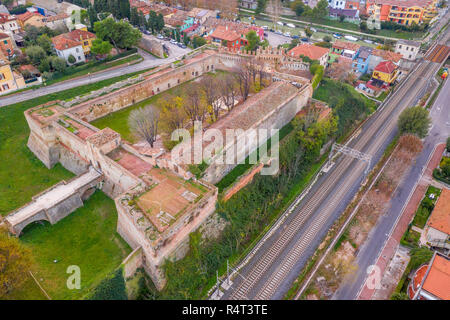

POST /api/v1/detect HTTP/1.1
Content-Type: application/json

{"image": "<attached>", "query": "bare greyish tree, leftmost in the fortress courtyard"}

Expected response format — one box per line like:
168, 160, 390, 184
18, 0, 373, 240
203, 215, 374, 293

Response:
128, 106, 159, 148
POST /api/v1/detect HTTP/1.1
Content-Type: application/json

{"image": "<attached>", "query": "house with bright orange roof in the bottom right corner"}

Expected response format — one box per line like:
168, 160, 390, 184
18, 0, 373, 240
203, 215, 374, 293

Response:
408, 252, 450, 300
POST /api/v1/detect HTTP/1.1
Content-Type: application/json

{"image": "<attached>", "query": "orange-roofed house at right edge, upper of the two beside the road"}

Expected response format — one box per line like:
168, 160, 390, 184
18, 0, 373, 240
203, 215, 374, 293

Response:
423, 188, 450, 250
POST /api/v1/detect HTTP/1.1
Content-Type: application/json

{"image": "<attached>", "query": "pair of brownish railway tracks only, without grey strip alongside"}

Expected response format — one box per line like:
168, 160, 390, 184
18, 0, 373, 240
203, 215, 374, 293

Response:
225, 61, 440, 299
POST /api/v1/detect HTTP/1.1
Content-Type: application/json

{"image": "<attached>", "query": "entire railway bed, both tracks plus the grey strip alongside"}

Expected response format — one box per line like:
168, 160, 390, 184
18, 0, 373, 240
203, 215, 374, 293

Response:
219, 36, 446, 299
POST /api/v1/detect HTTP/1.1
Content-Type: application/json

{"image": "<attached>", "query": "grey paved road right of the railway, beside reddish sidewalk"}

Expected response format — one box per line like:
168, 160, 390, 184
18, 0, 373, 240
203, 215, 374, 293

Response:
333, 55, 450, 300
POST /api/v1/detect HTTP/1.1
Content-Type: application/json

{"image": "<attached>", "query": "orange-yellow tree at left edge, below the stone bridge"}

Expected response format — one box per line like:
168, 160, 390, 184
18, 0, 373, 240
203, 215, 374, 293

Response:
0, 229, 32, 298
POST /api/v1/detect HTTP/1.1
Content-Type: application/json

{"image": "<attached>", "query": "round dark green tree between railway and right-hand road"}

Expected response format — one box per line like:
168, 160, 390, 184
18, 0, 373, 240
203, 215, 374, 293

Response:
398, 106, 431, 138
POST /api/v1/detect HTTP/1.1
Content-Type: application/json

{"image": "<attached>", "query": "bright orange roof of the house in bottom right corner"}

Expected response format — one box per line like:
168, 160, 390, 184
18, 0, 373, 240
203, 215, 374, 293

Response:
423, 255, 450, 300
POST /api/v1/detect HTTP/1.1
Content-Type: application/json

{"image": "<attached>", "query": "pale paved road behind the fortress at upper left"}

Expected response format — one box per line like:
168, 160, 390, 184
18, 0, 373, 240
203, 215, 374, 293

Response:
0, 47, 190, 107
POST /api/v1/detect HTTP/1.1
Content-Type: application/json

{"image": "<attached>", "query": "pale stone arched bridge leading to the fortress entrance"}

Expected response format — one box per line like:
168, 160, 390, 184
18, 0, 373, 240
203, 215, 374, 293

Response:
4, 167, 103, 236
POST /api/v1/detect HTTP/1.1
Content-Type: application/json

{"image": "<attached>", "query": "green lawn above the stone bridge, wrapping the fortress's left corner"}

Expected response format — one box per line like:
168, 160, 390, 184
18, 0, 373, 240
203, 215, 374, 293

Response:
0, 69, 152, 215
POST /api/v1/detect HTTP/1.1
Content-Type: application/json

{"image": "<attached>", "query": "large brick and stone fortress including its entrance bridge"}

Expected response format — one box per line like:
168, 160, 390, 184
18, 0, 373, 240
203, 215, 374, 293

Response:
4, 48, 313, 289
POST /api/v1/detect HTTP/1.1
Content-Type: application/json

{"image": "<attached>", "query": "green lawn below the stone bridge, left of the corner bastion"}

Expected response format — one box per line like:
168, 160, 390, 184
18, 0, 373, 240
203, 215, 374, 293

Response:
7, 191, 131, 299
